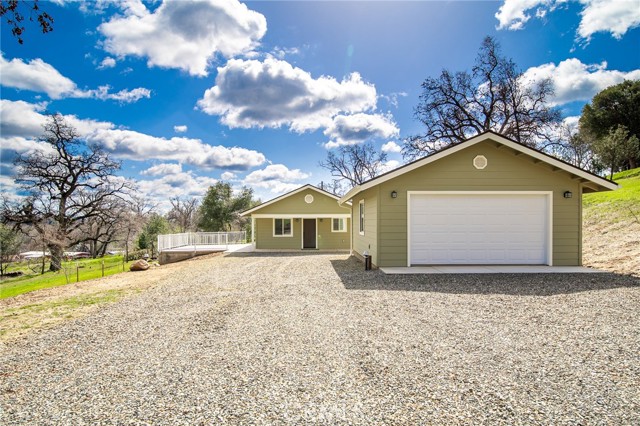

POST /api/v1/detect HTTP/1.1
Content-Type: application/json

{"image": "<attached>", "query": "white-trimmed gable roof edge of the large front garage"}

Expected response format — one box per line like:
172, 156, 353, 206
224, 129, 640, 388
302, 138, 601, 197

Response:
338, 130, 619, 204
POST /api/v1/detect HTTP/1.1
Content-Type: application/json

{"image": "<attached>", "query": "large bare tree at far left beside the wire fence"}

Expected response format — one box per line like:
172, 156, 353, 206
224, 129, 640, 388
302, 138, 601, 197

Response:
2, 114, 130, 271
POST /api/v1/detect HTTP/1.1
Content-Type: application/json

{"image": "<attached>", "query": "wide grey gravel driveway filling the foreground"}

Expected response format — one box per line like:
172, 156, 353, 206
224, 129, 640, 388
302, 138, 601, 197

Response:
0, 254, 640, 425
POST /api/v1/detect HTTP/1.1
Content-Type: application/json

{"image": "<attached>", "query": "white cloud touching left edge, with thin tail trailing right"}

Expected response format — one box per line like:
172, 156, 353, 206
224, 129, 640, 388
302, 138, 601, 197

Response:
0, 54, 151, 103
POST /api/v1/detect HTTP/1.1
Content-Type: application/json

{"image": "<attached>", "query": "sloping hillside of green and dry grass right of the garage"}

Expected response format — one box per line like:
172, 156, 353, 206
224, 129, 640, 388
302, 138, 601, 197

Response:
582, 168, 640, 276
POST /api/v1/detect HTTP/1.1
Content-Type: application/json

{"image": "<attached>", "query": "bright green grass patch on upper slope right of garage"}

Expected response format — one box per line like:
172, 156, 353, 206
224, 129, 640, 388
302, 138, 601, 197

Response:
582, 168, 640, 220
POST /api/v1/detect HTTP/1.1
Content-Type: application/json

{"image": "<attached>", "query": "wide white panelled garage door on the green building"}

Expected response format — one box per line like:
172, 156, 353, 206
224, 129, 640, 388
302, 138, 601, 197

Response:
409, 193, 551, 265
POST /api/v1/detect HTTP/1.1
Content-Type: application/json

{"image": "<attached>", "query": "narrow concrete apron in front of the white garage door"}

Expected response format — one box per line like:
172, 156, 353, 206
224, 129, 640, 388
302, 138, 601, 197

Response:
380, 265, 606, 274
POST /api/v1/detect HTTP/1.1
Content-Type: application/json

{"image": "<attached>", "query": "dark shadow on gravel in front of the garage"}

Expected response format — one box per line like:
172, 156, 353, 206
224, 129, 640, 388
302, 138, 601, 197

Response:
331, 257, 640, 296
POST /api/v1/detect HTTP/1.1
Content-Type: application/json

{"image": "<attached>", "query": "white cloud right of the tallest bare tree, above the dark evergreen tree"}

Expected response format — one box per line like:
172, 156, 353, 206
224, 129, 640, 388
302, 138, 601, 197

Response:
523, 58, 640, 105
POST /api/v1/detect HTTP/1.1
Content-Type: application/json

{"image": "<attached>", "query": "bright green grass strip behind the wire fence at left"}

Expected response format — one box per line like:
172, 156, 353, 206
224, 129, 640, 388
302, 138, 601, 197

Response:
0, 256, 131, 299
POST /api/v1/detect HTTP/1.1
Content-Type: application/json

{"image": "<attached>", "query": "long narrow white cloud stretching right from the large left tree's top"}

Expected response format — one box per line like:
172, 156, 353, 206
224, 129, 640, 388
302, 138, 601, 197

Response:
87, 129, 266, 170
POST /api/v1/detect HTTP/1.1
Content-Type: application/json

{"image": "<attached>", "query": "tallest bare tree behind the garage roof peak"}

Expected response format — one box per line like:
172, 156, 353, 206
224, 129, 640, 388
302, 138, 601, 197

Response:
402, 37, 561, 159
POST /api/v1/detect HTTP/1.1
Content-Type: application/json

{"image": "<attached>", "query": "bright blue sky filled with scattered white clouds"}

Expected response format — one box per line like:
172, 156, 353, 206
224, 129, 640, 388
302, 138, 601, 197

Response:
0, 0, 640, 208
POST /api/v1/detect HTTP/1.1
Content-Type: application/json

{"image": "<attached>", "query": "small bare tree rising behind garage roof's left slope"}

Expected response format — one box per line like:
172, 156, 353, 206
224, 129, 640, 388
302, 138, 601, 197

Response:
320, 142, 387, 187
